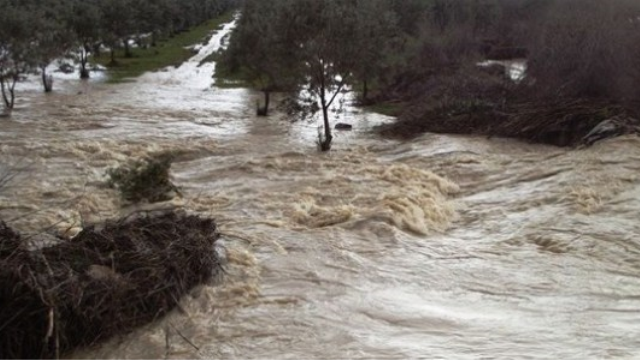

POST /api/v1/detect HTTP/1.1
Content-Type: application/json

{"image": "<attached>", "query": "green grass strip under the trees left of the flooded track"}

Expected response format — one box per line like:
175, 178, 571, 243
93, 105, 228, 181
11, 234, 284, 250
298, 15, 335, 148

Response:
93, 11, 234, 83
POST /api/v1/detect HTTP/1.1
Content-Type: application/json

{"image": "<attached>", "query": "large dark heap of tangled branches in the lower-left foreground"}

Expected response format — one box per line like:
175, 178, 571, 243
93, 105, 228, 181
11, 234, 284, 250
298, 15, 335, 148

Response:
0, 212, 221, 359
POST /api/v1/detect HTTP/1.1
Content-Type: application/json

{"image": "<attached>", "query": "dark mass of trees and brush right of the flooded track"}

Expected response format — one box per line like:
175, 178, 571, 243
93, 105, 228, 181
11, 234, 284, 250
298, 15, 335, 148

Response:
219, 0, 640, 149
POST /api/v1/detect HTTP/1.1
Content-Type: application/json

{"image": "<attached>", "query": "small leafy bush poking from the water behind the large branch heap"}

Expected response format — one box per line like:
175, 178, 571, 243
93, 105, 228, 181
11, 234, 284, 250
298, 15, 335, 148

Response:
107, 153, 178, 202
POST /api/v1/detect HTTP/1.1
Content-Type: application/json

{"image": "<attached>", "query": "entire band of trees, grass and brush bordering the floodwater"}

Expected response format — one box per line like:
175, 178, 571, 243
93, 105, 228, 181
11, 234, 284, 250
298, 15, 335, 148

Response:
0, 0, 640, 147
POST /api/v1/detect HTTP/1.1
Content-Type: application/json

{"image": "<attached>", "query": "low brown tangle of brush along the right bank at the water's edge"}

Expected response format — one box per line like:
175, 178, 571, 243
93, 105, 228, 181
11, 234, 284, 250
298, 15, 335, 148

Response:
383, 95, 640, 146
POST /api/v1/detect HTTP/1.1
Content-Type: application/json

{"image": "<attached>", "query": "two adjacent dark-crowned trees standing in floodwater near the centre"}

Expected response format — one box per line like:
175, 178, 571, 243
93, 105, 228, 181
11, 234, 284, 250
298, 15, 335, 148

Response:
220, 0, 397, 151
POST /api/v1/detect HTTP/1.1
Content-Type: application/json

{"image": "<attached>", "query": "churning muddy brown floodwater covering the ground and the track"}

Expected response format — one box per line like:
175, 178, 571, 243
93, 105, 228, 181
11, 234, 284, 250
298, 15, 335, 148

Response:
0, 17, 640, 360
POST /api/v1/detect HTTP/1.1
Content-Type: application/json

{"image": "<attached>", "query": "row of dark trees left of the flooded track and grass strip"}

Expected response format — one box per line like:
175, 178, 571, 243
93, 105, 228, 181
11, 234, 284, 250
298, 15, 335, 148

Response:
0, 0, 237, 108
